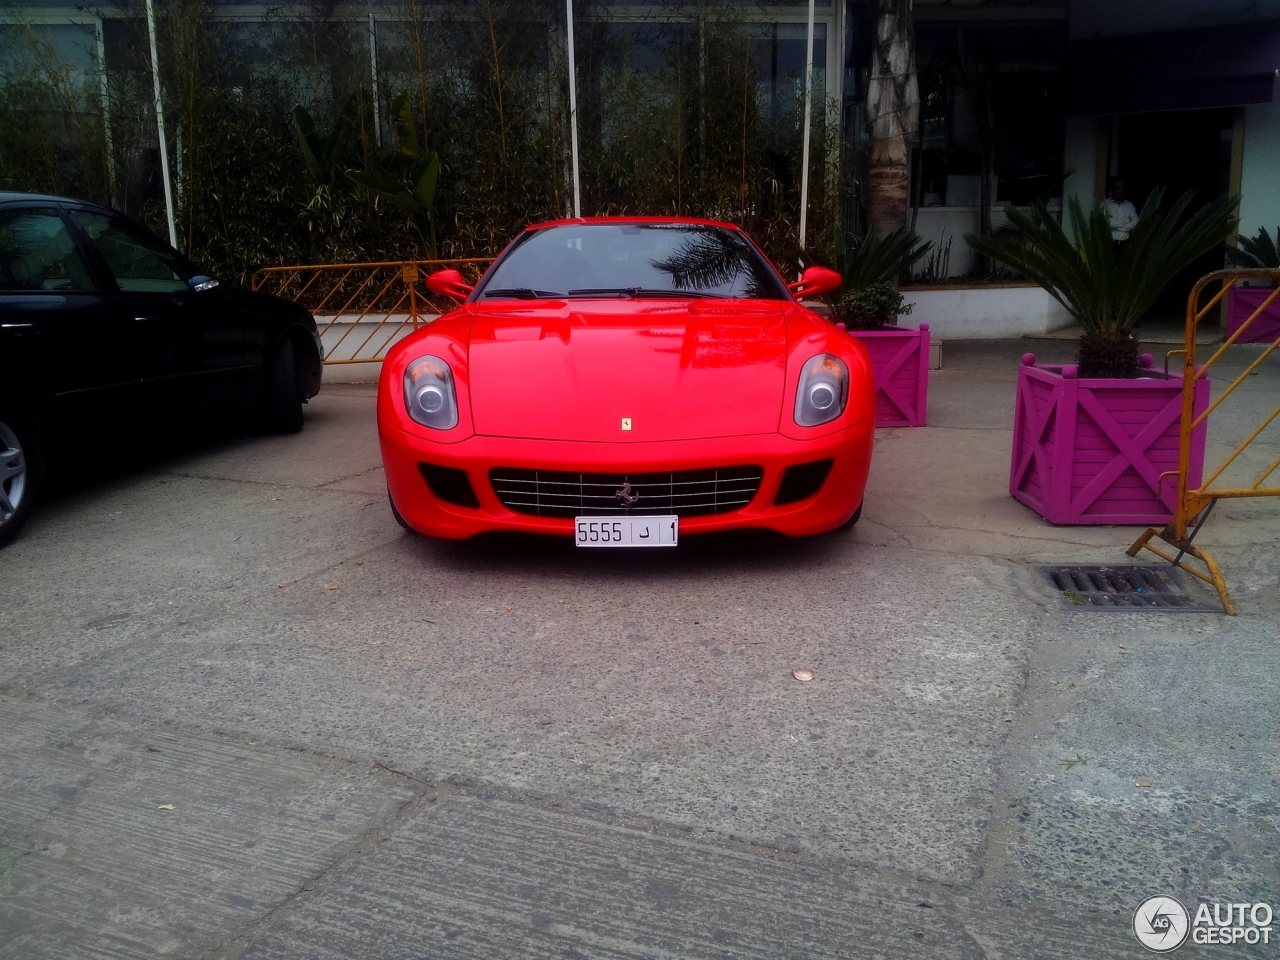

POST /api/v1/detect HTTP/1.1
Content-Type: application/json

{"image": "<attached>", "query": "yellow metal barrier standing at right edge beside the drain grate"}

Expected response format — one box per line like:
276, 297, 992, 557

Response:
1128, 270, 1280, 616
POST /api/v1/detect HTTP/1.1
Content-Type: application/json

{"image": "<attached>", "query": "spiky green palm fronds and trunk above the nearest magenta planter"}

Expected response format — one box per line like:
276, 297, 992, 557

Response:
965, 188, 1239, 378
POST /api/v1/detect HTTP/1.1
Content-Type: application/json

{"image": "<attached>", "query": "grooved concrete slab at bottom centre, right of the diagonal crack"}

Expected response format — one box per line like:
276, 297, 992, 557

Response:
241, 794, 980, 960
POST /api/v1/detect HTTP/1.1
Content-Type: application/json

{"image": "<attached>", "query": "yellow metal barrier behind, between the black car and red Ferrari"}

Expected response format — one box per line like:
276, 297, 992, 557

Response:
251, 257, 493, 364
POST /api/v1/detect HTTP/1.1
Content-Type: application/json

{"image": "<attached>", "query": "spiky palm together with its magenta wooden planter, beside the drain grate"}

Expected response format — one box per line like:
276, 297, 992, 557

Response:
968, 191, 1236, 525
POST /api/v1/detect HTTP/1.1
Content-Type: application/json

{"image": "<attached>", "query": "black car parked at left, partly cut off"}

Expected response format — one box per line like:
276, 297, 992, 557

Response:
0, 193, 323, 544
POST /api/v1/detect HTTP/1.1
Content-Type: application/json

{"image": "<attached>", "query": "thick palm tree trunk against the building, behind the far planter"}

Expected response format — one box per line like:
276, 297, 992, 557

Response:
867, 0, 920, 234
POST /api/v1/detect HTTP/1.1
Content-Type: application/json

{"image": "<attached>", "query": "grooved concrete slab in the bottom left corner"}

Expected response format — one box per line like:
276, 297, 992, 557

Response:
0, 696, 412, 959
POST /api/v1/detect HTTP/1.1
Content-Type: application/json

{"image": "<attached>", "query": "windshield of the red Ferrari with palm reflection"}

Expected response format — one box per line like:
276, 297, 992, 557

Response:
479, 223, 787, 300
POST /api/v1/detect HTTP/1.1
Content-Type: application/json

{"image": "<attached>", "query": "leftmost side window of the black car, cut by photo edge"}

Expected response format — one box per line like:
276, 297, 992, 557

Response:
0, 210, 93, 291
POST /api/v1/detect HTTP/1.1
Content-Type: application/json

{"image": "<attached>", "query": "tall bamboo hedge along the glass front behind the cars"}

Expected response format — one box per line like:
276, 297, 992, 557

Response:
0, 0, 849, 283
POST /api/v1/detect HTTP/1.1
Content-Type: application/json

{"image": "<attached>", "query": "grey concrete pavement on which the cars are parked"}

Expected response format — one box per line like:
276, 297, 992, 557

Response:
0, 342, 1280, 960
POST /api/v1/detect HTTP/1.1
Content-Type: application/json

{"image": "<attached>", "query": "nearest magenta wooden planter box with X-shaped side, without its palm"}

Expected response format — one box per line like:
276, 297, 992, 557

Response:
1009, 353, 1208, 526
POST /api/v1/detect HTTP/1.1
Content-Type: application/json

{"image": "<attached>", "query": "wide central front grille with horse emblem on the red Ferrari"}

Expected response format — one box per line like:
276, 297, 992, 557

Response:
489, 466, 764, 517
